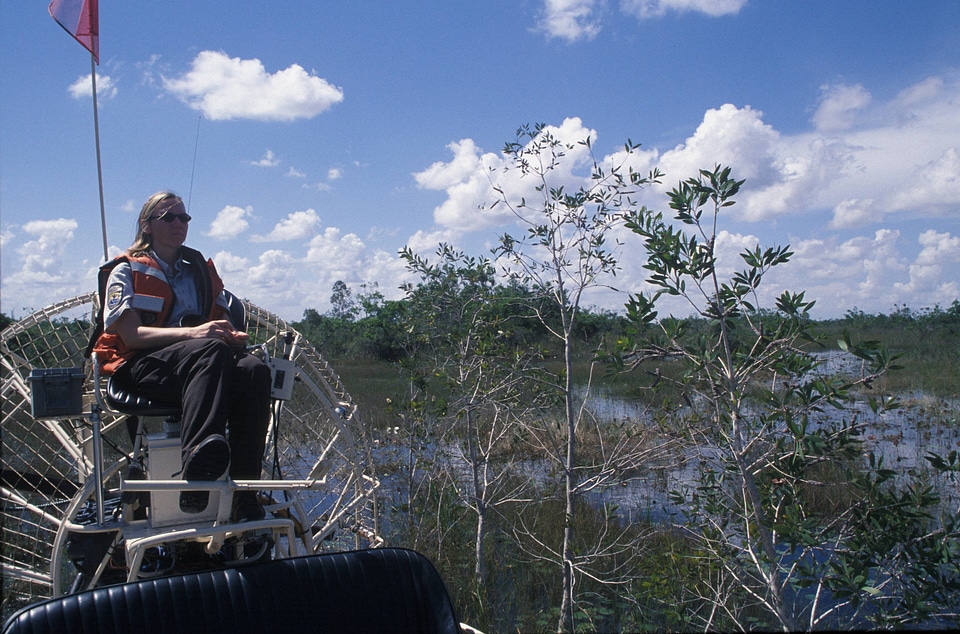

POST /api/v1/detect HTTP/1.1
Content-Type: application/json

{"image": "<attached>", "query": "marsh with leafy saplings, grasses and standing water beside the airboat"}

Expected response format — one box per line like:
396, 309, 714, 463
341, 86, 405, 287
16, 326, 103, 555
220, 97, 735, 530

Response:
299, 151, 960, 632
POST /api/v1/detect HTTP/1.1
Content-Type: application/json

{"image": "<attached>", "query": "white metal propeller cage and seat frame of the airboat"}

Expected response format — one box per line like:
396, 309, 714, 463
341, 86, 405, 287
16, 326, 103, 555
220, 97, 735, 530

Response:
0, 293, 382, 612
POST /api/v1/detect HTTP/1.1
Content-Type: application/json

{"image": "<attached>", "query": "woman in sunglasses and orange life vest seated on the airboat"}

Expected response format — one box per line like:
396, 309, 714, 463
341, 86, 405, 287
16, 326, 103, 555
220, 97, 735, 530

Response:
94, 192, 270, 521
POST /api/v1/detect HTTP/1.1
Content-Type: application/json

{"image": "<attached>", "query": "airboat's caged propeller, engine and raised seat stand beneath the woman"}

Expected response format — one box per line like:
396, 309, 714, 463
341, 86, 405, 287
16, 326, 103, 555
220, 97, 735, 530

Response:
0, 293, 383, 619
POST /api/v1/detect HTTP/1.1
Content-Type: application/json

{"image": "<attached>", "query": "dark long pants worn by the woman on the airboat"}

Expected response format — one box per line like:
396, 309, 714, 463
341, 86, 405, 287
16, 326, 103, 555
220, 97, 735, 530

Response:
117, 339, 270, 480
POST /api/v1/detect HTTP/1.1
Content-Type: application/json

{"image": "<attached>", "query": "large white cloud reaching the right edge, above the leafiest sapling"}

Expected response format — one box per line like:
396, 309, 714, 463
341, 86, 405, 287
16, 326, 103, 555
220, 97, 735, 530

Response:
640, 78, 960, 229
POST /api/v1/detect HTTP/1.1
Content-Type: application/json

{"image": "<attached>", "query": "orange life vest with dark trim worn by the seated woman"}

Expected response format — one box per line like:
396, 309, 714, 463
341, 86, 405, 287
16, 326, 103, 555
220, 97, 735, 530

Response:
88, 247, 223, 375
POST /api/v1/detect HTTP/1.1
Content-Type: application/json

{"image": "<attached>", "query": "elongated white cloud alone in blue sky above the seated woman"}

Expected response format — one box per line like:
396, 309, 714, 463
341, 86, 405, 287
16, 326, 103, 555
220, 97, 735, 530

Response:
163, 51, 343, 121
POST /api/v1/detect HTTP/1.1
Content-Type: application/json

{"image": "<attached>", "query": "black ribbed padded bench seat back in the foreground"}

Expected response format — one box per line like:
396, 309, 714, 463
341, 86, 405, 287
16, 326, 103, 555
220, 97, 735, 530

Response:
2, 548, 460, 634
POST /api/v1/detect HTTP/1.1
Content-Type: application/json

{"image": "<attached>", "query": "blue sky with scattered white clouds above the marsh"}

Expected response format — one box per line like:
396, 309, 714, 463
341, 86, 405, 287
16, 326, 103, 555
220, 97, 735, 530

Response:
0, 0, 960, 321
